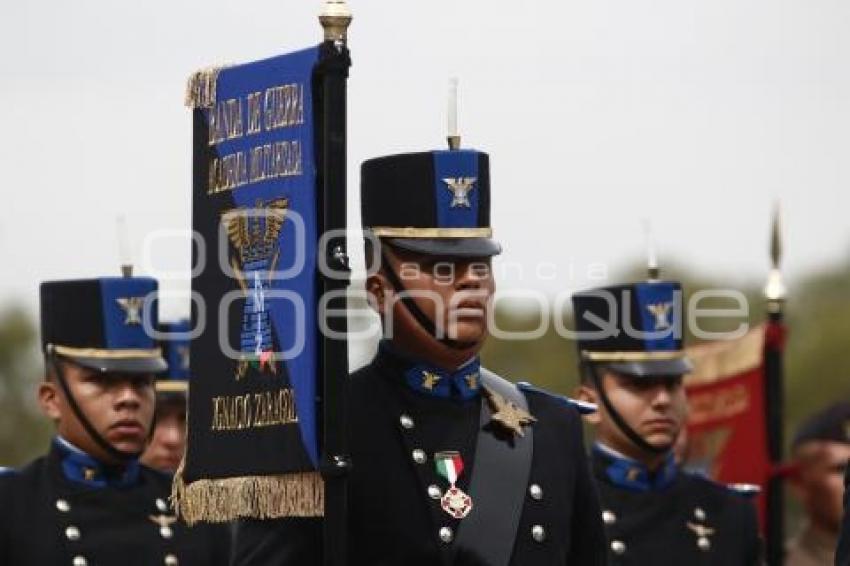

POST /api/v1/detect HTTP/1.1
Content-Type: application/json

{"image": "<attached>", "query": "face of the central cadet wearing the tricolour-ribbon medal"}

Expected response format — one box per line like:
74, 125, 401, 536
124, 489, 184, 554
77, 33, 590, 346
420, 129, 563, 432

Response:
367, 246, 495, 369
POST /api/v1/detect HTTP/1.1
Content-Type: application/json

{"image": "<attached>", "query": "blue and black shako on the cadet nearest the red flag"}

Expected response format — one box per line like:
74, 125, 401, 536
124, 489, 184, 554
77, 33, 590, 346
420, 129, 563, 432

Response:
572, 281, 692, 377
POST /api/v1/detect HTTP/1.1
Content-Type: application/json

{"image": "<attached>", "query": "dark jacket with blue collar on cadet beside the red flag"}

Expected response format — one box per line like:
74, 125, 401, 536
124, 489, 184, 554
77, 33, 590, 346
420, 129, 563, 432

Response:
592, 445, 761, 566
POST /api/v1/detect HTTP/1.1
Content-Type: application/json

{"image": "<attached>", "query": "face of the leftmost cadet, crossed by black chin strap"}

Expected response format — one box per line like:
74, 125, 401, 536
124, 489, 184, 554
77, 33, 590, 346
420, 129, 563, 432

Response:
39, 361, 154, 463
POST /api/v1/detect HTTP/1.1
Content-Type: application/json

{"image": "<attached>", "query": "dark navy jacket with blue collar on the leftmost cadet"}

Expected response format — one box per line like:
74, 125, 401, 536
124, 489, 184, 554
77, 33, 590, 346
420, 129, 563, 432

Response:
0, 439, 230, 566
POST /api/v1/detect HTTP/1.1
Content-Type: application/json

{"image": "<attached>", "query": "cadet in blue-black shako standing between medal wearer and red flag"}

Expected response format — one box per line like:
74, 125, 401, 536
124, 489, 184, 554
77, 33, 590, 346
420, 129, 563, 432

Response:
573, 281, 760, 566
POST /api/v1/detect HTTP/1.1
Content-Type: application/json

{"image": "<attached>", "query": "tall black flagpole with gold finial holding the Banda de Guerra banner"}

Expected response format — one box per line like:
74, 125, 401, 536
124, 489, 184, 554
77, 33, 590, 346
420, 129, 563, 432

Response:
316, 4, 351, 566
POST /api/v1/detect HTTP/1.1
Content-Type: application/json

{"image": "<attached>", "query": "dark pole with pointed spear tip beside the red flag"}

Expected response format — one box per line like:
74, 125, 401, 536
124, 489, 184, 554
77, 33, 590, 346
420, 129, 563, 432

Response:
764, 206, 786, 566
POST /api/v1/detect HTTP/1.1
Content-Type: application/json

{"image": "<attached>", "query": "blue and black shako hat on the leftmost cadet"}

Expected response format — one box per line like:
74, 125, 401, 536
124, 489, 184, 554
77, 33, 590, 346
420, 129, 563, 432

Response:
41, 277, 167, 373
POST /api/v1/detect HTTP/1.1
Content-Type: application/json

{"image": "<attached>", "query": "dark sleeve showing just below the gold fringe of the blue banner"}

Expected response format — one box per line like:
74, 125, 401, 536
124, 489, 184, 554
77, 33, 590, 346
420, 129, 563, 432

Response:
232, 518, 322, 566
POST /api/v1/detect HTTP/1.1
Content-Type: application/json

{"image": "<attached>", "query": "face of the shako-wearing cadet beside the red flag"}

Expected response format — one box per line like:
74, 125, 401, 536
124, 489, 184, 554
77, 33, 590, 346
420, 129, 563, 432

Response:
592, 371, 687, 460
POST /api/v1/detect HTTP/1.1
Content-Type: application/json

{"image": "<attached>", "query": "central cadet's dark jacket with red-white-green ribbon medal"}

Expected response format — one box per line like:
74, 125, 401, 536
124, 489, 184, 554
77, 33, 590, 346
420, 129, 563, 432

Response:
235, 347, 605, 566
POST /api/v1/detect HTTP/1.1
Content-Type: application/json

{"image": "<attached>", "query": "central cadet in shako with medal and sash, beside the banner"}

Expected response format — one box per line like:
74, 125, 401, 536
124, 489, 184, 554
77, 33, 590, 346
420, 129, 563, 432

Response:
236, 150, 605, 566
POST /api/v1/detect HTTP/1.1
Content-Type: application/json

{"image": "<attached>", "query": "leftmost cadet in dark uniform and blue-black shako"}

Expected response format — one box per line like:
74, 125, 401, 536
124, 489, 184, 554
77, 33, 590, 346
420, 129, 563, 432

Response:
0, 277, 227, 566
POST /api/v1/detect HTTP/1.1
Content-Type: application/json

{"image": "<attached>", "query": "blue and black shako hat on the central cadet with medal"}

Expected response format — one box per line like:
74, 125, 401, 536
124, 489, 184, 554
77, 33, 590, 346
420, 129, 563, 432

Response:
360, 149, 502, 257
